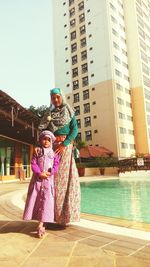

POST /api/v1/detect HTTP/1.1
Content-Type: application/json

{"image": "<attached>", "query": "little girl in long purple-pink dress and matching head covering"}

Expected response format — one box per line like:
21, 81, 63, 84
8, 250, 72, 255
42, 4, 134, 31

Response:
23, 130, 59, 237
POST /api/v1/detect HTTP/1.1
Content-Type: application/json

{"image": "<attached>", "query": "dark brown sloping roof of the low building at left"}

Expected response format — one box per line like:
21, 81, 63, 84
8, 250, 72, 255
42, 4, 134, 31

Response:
0, 90, 39, 143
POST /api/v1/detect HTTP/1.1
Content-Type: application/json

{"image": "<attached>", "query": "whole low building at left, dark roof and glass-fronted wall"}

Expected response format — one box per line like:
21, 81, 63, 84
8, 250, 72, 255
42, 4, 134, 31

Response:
0, 90, 39, 181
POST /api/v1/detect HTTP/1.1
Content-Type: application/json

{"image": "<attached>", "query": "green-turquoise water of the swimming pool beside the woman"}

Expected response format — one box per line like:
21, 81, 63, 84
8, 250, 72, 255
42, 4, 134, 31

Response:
81, 179, 150, 223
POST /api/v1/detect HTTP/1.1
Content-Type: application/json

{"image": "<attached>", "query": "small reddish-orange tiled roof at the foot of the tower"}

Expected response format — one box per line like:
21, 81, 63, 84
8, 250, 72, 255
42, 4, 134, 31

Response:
80, 146, 113, 158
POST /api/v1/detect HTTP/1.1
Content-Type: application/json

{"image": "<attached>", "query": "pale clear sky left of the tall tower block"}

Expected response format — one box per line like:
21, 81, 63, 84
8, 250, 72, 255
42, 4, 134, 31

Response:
0, 0, 54, 108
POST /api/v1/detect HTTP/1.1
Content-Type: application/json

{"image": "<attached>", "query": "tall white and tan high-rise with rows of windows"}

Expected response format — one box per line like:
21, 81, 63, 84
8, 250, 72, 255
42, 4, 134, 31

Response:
53, 0, 150, 158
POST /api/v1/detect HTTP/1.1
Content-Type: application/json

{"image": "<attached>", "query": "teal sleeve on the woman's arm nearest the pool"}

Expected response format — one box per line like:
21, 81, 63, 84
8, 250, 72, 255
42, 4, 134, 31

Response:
63, 115, 78, 146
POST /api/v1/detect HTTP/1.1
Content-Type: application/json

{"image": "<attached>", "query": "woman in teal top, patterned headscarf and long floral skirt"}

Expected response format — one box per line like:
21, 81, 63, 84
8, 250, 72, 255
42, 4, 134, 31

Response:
39, 88, 80, 225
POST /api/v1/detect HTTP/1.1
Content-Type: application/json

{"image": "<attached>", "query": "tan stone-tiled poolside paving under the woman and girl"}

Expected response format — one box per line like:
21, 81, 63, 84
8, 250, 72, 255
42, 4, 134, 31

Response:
0, 182, 150, 267
